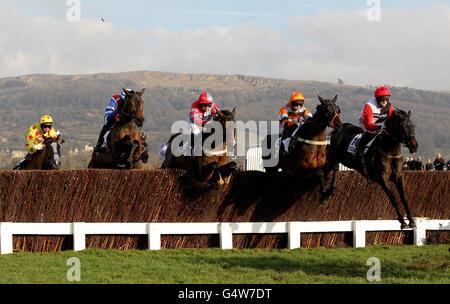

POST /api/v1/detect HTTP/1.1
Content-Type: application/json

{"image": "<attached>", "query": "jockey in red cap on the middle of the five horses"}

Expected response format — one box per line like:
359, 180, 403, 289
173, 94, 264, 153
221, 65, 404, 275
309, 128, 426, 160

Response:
187, 92, 219, 157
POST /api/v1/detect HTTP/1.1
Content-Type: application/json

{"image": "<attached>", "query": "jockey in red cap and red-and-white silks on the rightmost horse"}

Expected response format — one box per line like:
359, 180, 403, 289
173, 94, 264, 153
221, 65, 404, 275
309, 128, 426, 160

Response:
356, 87, 394, 171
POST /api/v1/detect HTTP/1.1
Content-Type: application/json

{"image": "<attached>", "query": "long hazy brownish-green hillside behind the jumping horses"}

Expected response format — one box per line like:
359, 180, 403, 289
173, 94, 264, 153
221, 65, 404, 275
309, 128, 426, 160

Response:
0, 71, 450, 167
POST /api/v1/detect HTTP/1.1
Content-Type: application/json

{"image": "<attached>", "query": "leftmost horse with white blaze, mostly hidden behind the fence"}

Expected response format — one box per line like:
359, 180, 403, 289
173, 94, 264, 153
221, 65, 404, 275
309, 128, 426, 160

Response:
13, 134, 65, 170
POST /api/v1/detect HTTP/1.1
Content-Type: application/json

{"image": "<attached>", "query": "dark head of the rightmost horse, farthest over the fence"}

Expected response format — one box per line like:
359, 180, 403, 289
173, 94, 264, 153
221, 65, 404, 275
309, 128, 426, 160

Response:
384, 110, 419, 153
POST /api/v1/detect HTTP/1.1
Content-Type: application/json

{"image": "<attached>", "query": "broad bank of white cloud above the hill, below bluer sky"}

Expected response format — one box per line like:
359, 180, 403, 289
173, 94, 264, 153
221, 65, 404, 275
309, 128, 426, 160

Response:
0, 4, 450, 90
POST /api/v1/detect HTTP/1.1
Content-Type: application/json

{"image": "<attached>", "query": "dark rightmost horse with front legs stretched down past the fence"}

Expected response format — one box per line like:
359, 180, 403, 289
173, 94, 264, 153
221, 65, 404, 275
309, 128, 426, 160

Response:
322, 110, 418, 229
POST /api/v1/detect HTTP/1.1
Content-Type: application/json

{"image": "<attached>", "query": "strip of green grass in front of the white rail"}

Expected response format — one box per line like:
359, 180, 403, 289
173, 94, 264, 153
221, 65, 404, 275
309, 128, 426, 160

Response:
0, 245, 450, 284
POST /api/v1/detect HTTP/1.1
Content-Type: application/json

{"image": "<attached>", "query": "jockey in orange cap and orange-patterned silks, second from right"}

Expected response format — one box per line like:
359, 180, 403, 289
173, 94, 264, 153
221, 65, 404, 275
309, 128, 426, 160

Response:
278, 92, 312, 150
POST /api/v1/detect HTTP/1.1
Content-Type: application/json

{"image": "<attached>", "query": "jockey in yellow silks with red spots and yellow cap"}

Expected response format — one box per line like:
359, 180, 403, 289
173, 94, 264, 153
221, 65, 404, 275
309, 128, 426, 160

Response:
14, 115, 59, 170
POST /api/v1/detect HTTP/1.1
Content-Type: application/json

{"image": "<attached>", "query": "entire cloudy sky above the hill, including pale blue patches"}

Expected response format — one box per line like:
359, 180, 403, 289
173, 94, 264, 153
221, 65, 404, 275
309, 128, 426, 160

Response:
0, 0, 450, 90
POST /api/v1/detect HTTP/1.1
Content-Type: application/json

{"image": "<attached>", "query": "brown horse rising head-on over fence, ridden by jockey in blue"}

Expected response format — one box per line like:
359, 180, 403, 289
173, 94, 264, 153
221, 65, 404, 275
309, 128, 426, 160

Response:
88, 89, 148, 169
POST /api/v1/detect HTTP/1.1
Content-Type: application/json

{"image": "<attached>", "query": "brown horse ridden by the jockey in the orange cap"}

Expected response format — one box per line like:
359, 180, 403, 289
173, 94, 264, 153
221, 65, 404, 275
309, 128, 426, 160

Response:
263, 95, 342, 193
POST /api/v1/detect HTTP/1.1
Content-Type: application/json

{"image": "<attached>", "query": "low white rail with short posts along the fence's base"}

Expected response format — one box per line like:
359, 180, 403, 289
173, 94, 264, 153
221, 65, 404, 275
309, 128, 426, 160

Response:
0, 218, 450, 254
